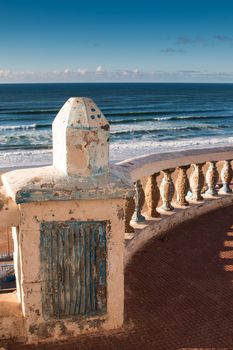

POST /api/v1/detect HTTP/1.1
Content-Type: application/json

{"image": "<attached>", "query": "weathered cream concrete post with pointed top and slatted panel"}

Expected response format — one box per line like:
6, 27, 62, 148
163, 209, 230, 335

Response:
2, 98, 134, 342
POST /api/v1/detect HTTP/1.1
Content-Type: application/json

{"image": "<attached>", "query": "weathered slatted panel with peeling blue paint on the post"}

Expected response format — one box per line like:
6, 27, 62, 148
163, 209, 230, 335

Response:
40, 221, 107, 318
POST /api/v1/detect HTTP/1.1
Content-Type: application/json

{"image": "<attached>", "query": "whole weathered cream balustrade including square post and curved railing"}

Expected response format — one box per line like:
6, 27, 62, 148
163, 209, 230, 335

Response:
0, 97, 233, 343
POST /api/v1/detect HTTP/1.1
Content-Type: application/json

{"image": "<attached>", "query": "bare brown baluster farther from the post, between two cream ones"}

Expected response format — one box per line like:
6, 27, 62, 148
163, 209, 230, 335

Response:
176, 165, 189, 207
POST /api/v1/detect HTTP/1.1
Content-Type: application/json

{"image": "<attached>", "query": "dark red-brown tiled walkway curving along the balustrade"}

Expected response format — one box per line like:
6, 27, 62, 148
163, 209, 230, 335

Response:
6, 207, 233, 350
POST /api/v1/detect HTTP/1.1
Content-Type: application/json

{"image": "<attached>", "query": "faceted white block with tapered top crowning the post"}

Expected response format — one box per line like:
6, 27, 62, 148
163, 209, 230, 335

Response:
53, 97, 110, 176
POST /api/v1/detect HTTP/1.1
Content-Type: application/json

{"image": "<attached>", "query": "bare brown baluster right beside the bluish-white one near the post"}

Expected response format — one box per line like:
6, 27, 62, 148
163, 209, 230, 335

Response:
145, 173, 160, 218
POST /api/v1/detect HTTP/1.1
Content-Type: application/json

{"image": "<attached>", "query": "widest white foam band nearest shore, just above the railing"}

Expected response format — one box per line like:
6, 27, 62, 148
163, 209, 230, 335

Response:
0, 137, 233, 170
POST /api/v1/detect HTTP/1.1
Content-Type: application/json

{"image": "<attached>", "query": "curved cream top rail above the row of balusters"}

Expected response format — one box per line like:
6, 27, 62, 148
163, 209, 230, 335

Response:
117, 146, 233, 181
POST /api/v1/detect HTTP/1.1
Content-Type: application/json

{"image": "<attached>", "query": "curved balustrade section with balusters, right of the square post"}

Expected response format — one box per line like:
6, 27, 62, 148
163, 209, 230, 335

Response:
118, 147, 233, 264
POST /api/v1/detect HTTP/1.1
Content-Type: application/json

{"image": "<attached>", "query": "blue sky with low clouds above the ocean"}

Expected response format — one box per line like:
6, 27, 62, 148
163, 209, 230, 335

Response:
0, 0, 233, 83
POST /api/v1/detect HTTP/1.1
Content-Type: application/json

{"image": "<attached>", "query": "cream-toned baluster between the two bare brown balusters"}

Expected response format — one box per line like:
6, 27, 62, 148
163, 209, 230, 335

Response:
160, 169, 174, 211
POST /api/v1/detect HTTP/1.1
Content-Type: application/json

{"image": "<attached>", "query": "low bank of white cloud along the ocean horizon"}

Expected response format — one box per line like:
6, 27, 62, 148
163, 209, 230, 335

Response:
0, 65, 233, 83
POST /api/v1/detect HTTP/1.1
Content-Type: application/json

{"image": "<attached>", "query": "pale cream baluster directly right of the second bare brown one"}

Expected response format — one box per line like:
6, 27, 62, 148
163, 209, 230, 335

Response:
189, 163, 205, 201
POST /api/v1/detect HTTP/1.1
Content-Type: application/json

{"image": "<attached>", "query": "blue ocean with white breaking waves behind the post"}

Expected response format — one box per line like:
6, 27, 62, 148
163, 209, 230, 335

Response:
0, 83, 233, 168
